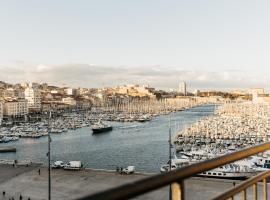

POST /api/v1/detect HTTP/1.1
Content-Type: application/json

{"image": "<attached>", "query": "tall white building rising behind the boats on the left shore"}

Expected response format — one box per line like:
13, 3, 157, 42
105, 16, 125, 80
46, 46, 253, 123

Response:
24, 87, 41, 111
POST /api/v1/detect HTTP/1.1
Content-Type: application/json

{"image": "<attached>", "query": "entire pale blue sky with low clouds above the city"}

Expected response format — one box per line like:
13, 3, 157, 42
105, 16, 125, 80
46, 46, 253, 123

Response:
0, 0, 270, 89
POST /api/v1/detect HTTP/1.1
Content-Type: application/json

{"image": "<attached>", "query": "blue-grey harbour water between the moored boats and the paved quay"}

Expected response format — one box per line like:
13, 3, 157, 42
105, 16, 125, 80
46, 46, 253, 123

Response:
0, 105, 215, 172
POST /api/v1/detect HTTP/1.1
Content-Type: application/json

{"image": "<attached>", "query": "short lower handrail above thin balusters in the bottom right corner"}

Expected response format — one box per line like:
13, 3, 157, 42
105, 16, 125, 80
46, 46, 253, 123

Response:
212, 170, 270, 200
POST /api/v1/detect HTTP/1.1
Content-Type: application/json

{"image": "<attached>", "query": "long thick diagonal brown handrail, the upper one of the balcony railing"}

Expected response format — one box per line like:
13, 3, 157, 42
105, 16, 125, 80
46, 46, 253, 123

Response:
79, 142, 270, 200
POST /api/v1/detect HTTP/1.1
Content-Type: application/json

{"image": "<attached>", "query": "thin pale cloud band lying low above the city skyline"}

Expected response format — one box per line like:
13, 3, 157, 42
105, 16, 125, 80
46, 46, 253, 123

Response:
0, 61, 270, 89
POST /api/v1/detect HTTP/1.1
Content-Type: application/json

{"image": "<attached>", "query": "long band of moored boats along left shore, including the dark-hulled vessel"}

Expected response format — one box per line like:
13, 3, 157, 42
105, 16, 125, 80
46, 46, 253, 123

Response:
0, 99, 205, 142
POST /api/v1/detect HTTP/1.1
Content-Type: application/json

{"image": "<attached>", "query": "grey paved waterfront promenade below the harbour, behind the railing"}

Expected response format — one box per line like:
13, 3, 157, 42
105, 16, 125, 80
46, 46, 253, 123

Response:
0, 165, 270, 200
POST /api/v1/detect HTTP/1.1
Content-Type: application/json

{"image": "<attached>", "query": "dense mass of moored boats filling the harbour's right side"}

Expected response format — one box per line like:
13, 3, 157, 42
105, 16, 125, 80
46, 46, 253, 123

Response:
160, 103, 270, 179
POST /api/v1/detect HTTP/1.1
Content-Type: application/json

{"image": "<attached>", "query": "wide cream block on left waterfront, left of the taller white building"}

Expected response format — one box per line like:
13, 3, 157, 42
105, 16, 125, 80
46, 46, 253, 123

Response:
3, 99, 28, 117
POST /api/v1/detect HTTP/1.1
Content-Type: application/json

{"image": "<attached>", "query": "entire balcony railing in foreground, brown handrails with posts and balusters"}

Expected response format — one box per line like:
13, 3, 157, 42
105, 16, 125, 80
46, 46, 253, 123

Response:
76, 142, 270, 200
